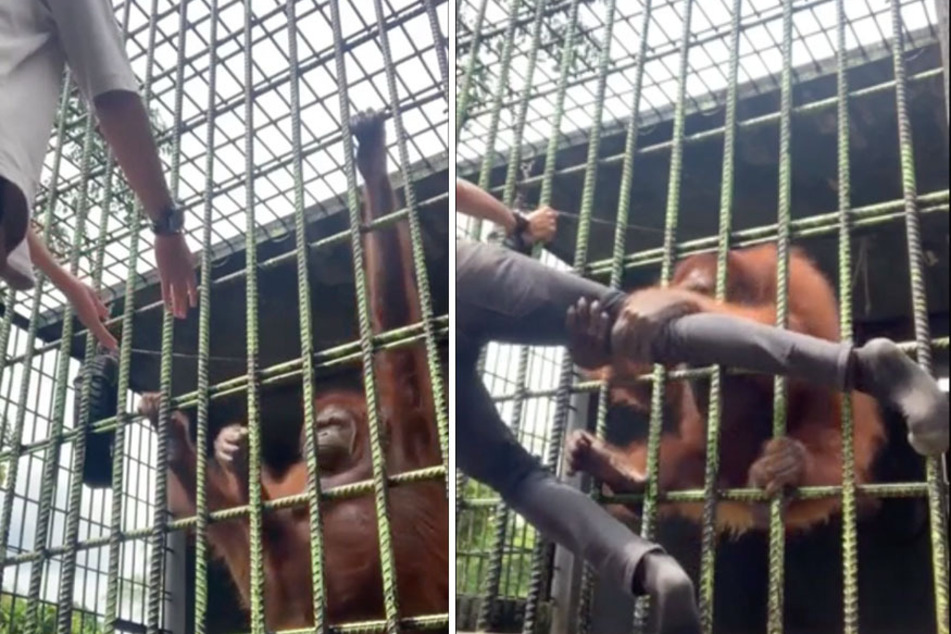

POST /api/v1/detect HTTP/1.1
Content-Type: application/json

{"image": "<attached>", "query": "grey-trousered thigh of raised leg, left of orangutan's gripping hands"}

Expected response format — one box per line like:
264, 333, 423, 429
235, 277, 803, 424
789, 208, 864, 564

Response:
456, 242, 625, 346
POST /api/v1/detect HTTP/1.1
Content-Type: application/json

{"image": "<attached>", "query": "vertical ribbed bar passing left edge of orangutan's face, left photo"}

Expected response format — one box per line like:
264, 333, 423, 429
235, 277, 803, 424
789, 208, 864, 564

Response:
287, 0, 330, 633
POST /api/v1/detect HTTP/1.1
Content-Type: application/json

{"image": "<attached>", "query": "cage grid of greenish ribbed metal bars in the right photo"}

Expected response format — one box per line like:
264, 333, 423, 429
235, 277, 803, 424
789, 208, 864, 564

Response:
456, 0, 949, 633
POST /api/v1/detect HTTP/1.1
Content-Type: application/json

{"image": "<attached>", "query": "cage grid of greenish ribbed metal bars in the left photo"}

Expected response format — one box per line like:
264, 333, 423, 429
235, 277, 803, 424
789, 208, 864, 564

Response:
0, 0, 448, 632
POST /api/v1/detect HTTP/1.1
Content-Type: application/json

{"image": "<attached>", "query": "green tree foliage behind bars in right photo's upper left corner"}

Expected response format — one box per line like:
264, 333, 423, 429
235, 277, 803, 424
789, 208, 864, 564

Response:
456, 0, 604, 119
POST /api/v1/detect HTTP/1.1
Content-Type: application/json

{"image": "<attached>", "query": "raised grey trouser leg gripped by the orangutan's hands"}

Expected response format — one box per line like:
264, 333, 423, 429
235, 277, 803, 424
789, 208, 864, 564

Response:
456, 242, 852, 390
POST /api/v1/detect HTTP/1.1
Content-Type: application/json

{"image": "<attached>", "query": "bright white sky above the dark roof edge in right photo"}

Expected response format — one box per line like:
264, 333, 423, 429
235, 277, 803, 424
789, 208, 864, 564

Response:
459, 0, 935, 161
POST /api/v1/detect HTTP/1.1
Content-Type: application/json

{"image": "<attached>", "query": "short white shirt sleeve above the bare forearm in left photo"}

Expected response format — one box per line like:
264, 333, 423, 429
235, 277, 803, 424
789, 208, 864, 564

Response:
47, 0, 139, 102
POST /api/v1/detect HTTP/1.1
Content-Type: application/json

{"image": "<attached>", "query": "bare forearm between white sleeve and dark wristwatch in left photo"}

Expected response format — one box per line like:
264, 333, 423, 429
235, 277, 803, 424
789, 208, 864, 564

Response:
94, 91, 172, 219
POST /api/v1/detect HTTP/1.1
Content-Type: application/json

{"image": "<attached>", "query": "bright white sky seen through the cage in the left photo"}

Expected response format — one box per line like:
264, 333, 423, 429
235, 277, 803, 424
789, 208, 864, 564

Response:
18, 0, 448, 317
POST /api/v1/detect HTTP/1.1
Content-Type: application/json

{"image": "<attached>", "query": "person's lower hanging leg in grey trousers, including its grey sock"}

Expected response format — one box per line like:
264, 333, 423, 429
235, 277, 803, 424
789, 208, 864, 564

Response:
456, 353, 699, 633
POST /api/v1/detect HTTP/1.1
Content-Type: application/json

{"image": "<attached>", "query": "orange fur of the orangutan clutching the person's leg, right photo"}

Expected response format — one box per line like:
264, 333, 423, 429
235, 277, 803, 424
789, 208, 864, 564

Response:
584, 245, 885, 533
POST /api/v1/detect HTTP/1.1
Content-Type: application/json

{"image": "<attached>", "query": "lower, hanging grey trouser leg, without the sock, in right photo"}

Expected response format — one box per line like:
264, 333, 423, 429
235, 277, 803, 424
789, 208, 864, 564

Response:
455, 348, 661, 592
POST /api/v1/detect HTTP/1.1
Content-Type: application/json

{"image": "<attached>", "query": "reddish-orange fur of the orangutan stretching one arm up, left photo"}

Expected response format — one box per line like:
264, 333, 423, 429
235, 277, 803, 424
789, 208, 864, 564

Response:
162, 112, 449, 632
